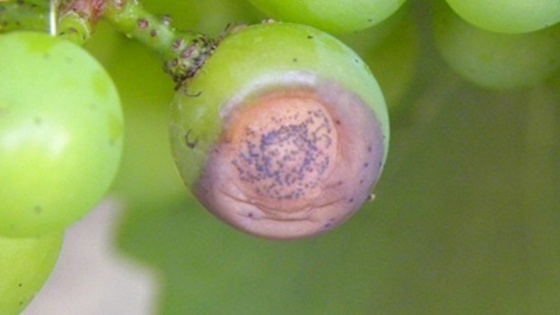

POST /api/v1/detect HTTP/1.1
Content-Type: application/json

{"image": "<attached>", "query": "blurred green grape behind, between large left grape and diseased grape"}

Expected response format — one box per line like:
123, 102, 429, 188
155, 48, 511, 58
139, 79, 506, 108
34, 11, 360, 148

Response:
98, 32, 184, 205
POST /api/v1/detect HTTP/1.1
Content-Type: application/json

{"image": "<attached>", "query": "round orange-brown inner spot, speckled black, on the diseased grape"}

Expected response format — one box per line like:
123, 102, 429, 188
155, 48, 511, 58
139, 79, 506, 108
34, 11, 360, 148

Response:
226, 93, 337, 212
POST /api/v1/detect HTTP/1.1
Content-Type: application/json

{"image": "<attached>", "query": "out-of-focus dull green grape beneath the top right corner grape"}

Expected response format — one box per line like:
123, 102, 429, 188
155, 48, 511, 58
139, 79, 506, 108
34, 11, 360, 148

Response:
434, 5, 560, 89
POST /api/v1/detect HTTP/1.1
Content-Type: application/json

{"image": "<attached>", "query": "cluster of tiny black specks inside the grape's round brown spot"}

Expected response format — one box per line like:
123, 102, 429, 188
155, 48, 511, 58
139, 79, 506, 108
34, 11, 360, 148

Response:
232, 109, 335, 200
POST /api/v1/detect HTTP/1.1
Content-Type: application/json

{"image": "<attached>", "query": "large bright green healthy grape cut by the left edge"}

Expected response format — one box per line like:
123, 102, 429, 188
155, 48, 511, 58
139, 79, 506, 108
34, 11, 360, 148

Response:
0, 32, 123, 237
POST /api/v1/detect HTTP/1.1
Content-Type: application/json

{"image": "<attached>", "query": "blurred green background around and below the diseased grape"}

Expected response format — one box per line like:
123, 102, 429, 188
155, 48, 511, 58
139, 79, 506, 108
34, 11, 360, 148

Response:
84, 0, 560, 315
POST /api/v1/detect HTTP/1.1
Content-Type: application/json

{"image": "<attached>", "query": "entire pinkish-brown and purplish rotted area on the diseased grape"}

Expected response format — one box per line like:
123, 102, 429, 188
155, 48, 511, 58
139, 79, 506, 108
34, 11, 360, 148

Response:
196, 85, 383, 239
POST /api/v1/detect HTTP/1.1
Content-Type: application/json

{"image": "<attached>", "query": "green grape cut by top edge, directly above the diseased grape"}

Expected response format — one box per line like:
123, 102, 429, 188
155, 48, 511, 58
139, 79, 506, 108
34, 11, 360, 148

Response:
249, 0, 405, 34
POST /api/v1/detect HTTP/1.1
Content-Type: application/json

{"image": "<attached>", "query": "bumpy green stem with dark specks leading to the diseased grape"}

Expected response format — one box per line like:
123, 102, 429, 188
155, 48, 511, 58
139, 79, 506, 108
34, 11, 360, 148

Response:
59, 0, 215, 85
